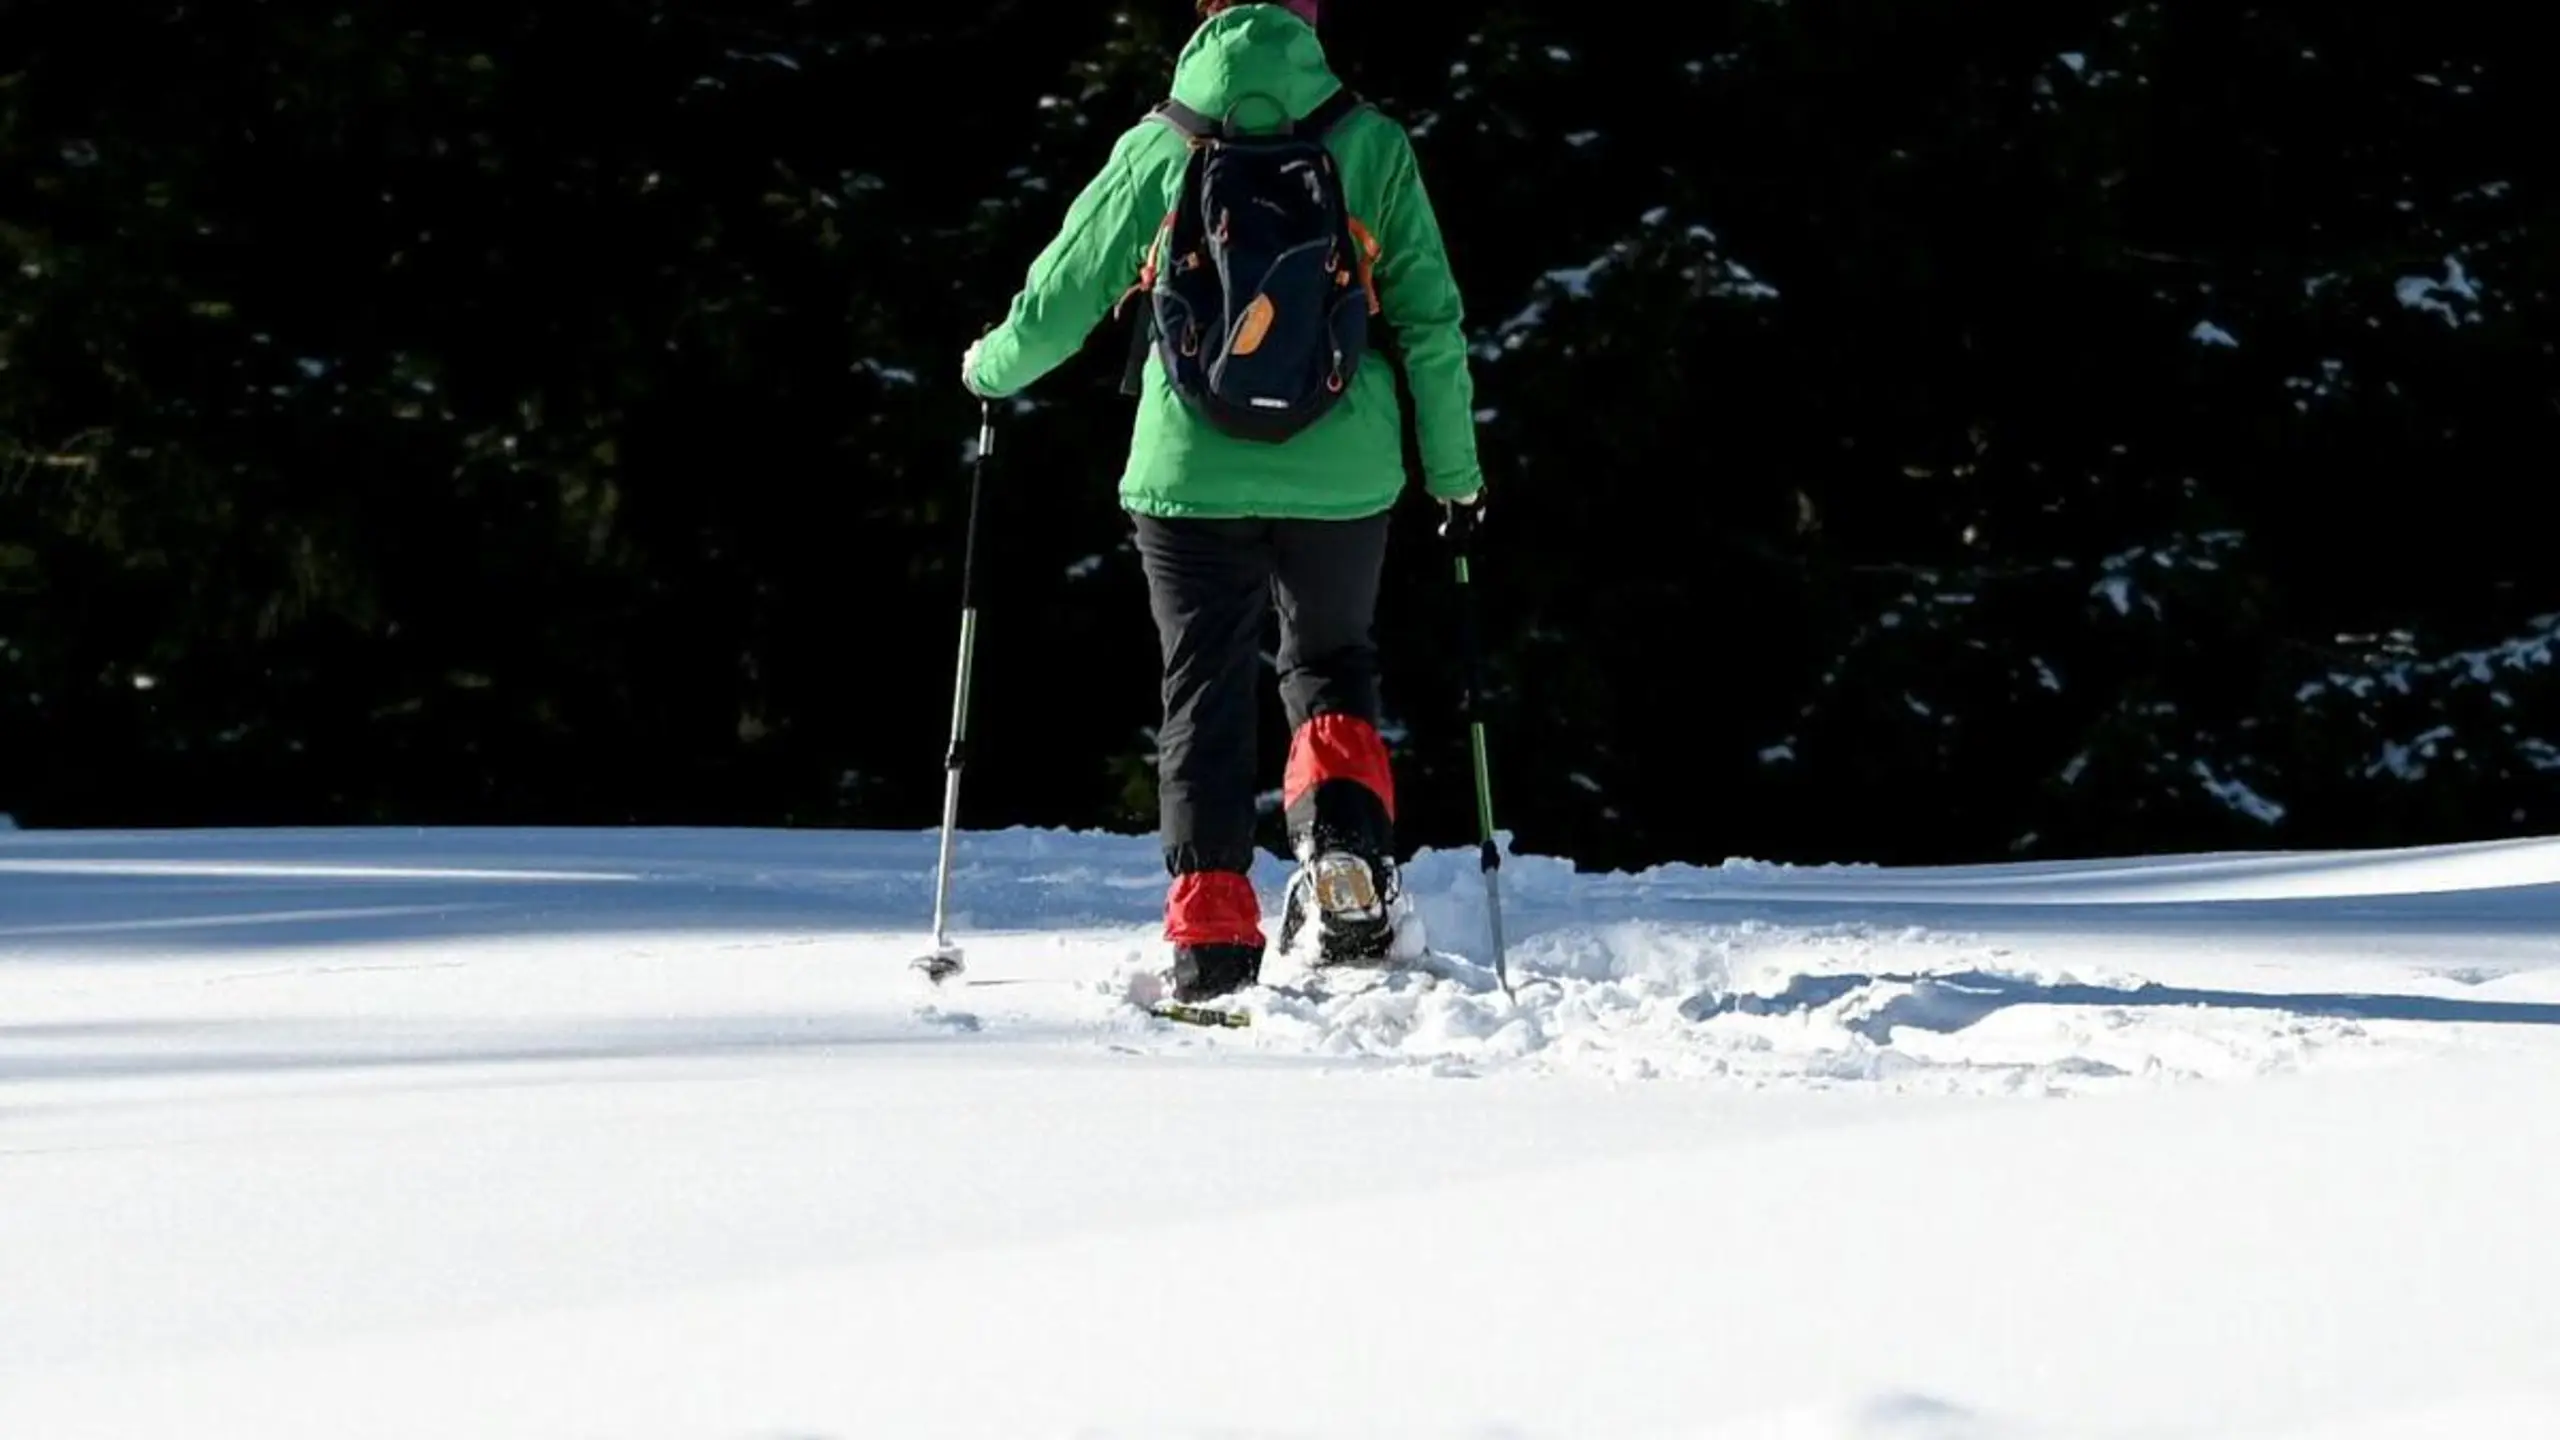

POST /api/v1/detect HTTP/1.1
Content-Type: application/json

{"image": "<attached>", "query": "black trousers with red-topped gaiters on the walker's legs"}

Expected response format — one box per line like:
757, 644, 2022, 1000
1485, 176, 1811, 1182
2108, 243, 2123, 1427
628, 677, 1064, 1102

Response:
1134, 512, 1393, 943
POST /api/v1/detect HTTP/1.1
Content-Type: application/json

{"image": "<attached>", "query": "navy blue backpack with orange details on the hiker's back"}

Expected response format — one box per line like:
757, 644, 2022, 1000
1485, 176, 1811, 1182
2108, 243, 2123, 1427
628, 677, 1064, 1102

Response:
1114, 87, 1377, 443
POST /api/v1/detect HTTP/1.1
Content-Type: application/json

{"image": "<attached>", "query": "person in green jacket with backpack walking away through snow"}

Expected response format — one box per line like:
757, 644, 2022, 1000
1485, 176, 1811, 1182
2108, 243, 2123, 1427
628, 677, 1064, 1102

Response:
960, 0, 1485, 999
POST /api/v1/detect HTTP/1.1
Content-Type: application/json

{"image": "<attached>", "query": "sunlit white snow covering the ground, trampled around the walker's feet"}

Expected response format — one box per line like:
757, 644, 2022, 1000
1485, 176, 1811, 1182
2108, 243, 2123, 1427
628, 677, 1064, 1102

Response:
0, 830, 2560, 1440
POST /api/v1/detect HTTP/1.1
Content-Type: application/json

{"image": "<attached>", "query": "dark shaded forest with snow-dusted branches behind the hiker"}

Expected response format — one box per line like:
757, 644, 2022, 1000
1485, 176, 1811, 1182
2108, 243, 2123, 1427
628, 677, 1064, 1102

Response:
0, 0, 2560, 866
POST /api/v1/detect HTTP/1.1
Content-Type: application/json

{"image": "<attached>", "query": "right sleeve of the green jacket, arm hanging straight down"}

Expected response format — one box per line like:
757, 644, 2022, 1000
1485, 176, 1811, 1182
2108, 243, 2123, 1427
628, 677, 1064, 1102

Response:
1377, 128, 1485, 500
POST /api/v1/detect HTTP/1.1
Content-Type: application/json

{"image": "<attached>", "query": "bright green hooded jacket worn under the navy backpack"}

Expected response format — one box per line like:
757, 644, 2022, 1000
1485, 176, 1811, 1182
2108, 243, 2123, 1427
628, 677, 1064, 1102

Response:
970, 5, 1482, 520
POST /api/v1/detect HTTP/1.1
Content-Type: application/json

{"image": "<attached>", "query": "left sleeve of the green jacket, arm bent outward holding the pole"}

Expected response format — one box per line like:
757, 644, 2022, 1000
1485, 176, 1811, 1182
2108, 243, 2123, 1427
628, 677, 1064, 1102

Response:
975, 131, 1162, 397
